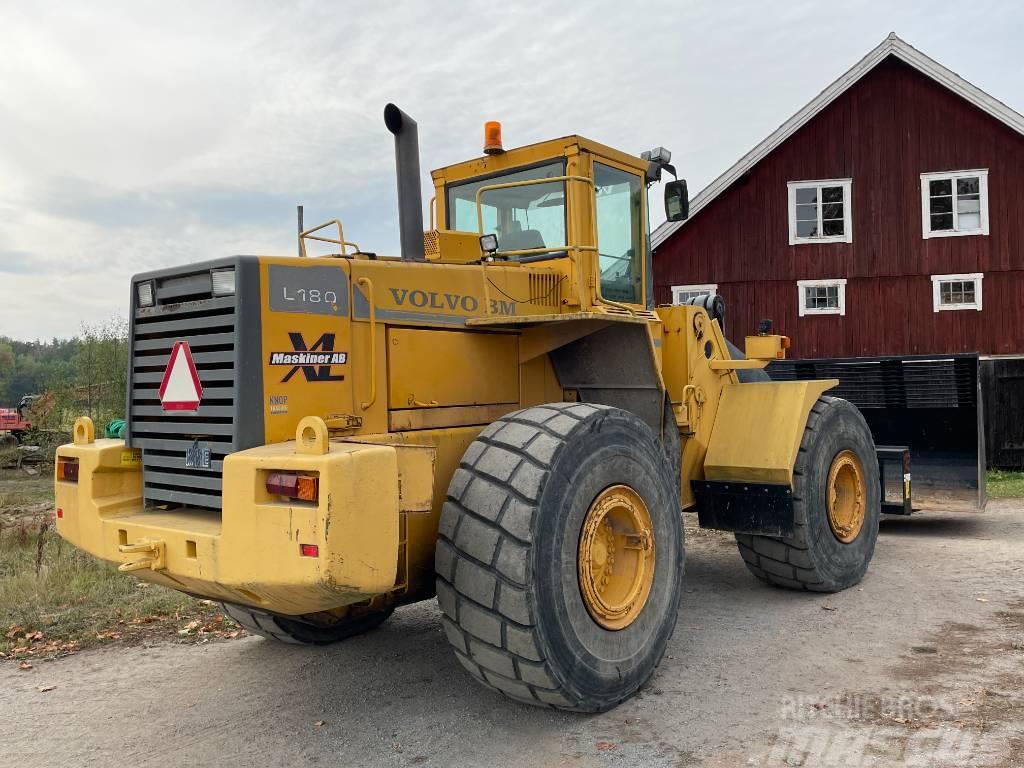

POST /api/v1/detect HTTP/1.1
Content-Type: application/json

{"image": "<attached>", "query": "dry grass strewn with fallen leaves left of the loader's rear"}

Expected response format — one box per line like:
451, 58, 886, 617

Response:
0, 475, 239, 658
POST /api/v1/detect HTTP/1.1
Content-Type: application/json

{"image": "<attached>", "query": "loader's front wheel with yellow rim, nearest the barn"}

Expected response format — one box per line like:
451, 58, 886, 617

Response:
736, 396, 882, 592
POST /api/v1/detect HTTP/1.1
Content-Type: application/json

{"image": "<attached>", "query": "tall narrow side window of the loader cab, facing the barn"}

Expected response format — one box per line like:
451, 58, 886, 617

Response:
594, 163, 643, 304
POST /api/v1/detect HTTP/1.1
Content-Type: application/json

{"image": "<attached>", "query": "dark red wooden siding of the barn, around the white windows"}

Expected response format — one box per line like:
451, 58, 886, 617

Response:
654, 57, 1024, 357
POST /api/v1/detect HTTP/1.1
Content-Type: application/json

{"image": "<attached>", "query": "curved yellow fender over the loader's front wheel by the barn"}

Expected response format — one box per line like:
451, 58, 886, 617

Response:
703, 379, 839, 484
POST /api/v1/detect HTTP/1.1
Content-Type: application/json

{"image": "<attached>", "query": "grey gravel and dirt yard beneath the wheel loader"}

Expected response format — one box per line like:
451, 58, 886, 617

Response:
0, 501, 1024, 768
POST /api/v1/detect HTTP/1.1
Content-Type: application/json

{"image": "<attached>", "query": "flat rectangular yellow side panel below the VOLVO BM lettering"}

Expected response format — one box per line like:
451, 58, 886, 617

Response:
388, 328, 519, 409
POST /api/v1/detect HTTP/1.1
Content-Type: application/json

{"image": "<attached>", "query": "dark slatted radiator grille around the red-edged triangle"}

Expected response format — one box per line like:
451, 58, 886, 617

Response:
128, 286, 238, 509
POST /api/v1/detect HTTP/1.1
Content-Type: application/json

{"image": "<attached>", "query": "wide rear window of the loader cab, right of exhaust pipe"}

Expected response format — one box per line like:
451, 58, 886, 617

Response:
446, 162, 565, 253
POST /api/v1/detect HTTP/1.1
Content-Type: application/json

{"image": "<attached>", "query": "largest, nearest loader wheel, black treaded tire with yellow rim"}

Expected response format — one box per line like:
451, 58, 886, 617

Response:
436, 403, 683, 712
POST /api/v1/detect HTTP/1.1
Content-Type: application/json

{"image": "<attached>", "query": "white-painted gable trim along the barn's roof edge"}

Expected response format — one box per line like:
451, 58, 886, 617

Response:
650, 32, 1024, 248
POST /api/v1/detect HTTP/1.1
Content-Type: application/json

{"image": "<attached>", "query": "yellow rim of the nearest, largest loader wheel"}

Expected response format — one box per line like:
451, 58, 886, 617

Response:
578, 485, 654, 630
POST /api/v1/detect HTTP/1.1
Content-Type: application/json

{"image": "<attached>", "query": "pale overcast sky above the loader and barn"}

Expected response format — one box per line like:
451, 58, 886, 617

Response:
0, 0, 1024, 339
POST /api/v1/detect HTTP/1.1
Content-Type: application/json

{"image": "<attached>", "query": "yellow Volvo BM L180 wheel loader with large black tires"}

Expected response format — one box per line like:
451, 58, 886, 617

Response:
55, 105, 880, 712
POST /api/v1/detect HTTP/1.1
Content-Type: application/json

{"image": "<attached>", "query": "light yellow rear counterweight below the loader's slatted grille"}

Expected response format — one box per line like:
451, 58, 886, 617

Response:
56, 440, 436, 614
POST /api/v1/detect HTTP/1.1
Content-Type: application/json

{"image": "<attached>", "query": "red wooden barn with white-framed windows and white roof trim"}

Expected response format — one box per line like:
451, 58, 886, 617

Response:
651, 35, 1024, 358
